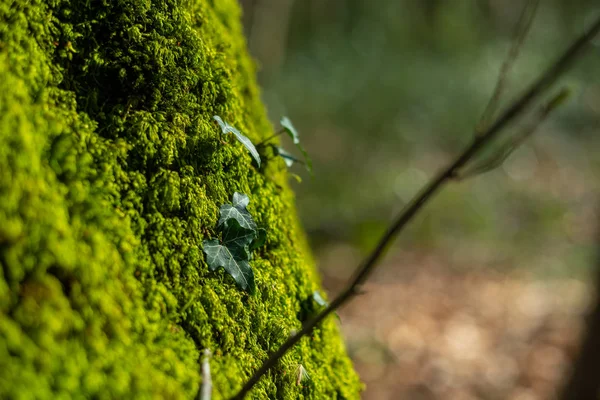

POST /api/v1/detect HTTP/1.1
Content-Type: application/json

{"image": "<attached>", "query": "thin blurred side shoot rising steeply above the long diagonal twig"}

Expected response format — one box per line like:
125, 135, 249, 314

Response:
475, 0, 540, 134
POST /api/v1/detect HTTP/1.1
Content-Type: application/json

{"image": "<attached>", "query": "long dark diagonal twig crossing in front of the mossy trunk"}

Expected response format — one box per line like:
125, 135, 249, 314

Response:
232, 13, 600, 400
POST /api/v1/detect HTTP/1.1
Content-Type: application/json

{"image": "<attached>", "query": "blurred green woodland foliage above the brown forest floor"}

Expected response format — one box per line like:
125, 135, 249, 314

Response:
242, 0, 600, 276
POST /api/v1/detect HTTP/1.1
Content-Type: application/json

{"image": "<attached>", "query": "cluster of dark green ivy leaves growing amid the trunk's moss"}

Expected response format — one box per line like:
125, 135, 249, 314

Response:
202, 192, 267, 294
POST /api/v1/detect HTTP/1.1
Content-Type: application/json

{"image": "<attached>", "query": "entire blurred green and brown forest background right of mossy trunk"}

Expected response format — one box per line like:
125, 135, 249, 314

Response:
241, 0, 600, 400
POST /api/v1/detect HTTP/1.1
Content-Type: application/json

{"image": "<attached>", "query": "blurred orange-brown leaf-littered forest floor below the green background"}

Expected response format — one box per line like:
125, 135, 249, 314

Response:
325, 255, 593, 400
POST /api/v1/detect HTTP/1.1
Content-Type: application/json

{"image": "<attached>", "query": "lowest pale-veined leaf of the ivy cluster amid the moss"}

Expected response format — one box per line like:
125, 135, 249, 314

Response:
202, 239, 255, 294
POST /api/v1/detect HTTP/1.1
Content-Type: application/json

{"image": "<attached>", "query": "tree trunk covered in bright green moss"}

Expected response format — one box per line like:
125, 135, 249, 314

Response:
0, 0, 360, 399
